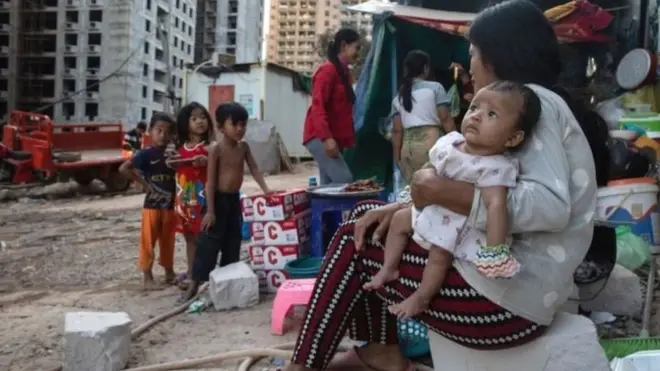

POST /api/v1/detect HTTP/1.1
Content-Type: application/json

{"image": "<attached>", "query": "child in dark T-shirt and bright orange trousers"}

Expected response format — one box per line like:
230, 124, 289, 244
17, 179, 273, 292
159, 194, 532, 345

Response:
119, 113, 176, 290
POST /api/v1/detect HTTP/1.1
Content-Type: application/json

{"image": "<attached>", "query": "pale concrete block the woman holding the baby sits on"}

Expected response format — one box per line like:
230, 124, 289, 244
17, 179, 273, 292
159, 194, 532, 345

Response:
429, 313, 610, 371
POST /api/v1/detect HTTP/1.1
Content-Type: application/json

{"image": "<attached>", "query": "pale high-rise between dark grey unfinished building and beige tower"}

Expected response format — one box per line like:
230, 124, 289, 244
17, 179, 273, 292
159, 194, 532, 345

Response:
195, 0, 264, 63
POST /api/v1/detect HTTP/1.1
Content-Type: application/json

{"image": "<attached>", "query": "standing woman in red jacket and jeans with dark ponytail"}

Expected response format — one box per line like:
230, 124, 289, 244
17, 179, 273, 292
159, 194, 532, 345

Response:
303, 28, 360, 184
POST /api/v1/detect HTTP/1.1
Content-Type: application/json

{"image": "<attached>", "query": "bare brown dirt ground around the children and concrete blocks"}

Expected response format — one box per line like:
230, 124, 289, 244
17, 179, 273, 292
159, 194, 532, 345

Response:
0, 164, 316, 371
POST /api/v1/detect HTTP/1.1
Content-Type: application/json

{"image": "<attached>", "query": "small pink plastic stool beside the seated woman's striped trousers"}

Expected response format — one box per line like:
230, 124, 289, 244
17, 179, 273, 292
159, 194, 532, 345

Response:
270, 278, 316, 335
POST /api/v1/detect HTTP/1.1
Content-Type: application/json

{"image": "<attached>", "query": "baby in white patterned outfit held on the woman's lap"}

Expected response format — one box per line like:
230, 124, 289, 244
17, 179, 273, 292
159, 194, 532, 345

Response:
365, 81, 541, 318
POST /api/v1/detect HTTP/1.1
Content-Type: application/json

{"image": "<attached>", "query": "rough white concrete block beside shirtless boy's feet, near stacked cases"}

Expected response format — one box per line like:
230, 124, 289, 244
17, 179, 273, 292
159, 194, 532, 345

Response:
209, 262, 259, 310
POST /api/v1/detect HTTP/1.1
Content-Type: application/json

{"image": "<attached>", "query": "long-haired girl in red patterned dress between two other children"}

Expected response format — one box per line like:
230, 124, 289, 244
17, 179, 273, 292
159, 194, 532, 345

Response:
168, 102, 213, 290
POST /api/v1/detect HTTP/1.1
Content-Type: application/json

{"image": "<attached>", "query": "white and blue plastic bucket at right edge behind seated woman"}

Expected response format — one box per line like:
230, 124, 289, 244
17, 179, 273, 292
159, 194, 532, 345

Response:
596, 182, 660, 245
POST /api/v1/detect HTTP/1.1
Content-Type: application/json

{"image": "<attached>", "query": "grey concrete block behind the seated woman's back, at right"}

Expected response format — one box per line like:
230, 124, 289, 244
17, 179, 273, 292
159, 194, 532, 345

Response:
580, 265, 644, 316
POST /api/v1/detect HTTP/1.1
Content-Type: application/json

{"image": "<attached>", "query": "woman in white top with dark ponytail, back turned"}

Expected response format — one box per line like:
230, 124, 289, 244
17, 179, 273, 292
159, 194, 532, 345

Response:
390, 50, 455, 184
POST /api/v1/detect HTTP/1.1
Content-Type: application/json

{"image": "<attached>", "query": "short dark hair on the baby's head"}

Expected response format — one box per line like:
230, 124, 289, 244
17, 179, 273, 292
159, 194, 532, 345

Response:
484, 80, 541, 151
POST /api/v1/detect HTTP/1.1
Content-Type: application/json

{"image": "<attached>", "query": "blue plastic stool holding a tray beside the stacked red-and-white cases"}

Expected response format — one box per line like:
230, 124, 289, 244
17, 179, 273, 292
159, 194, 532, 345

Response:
310, 194, 375, 258
